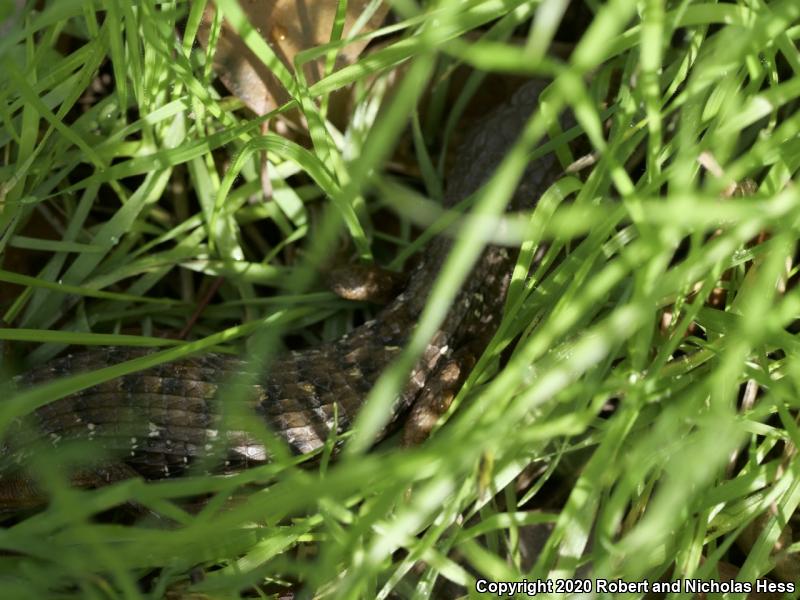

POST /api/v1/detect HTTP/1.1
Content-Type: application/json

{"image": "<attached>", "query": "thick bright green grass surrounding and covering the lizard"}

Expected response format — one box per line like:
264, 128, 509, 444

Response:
0, 0, 800, 598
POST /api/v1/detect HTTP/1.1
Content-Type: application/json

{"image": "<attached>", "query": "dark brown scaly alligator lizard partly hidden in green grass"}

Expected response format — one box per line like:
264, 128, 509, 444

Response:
0, 82, 561, 507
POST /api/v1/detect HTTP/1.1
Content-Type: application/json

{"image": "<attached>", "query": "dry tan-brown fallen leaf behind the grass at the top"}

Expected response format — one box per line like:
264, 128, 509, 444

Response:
198, 0, 388, 115
